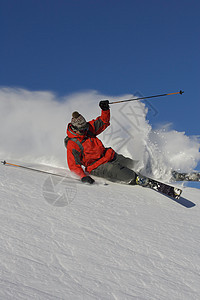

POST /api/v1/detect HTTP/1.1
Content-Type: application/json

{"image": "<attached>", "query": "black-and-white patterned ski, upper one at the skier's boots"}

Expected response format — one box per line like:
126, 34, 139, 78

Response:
136, 175, 182, 199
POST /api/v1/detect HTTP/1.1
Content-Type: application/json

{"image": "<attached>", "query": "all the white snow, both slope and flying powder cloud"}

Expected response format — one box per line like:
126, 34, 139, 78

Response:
0, 88, 200, 300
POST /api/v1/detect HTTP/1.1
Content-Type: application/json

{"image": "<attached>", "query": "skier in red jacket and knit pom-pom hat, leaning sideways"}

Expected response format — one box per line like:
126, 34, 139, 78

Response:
65, 100, 137, 184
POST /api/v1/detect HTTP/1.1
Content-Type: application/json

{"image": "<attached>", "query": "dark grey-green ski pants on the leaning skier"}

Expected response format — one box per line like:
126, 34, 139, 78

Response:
91, 153, 137, 184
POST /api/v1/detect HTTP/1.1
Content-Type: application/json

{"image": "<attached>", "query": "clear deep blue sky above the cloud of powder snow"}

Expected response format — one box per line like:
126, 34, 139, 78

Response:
0, 0, 200, 135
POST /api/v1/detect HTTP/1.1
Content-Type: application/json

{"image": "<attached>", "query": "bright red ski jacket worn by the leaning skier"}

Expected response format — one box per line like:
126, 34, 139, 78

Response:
65, 110, 115, 178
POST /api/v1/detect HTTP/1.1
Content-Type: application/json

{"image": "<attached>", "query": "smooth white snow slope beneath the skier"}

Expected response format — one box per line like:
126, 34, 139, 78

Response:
0, 166, 200, 300
